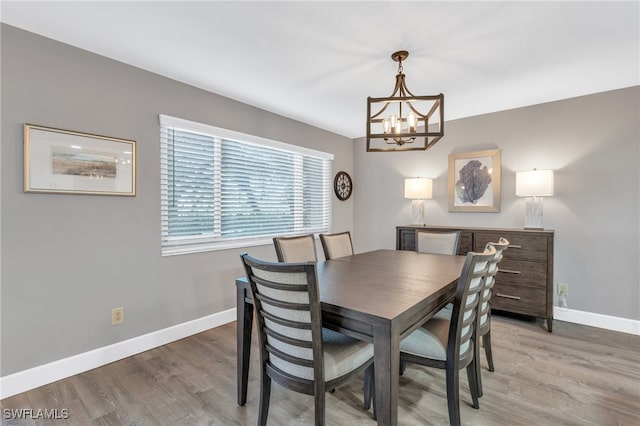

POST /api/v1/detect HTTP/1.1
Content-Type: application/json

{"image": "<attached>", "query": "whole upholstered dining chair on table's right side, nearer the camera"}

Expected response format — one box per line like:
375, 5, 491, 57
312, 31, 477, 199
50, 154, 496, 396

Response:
400, 246, 496, 426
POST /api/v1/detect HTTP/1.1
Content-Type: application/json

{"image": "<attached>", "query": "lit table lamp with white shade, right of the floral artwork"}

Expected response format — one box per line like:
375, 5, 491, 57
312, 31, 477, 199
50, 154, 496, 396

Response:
516, 169, 553, 229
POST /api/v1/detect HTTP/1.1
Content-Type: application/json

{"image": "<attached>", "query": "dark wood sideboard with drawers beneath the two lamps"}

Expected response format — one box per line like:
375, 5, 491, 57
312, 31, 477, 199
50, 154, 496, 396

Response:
396, 225, 554, 332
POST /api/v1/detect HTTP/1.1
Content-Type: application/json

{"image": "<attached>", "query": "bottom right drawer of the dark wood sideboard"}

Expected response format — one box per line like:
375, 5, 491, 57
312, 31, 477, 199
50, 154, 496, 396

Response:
491, 281, 546, 316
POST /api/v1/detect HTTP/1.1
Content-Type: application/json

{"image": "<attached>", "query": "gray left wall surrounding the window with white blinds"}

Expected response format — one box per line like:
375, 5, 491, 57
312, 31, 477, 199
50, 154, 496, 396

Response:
0, 24, 353, 376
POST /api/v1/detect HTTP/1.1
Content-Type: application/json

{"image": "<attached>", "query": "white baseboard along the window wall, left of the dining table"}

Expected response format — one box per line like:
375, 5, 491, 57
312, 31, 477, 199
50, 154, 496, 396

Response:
0, 308, 236, 399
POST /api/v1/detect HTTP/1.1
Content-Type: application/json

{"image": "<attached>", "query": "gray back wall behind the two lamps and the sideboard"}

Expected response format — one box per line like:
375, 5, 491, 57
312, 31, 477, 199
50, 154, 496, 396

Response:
354, 87, 640, 320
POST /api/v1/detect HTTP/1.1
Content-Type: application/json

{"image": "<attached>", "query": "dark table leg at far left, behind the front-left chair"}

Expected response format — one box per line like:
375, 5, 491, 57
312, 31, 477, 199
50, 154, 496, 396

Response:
236, 284, 253, 405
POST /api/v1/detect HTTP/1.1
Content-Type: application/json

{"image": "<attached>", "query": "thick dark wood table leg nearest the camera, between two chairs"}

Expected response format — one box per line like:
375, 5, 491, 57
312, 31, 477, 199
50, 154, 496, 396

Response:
373, 325, 400, 426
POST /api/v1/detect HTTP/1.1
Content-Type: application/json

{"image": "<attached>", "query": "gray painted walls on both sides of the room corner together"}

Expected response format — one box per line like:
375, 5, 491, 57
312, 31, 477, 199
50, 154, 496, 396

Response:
0, 24, 640, 376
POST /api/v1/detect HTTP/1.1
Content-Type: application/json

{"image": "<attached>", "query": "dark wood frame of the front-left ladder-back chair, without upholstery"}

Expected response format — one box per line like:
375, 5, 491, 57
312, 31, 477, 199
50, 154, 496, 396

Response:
241, 253, 375, 426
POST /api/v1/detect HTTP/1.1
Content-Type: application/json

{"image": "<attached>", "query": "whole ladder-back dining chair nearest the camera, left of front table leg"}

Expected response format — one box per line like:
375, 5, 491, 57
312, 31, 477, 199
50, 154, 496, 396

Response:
241, 253, 373, 425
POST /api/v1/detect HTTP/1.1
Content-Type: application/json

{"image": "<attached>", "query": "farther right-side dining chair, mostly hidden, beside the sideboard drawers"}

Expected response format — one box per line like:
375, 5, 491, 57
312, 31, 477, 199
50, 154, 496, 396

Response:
475, 237, 509, 396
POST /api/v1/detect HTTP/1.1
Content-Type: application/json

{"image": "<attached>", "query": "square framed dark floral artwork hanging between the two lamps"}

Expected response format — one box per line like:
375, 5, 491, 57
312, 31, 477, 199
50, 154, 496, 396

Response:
449, 149, 500, 212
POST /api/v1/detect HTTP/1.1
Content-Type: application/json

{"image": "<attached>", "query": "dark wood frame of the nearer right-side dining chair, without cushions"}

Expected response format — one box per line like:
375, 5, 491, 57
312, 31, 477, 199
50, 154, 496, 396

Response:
396, 247, 495, 426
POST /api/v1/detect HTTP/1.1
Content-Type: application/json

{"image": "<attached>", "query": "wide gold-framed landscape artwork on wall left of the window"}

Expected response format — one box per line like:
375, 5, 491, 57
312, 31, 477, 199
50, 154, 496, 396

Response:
24, 124, 136, 196
